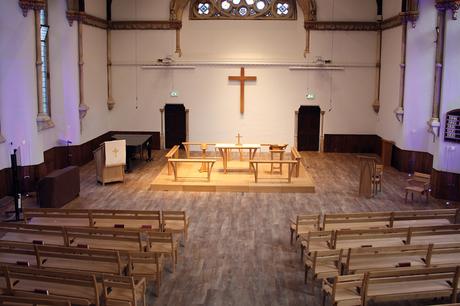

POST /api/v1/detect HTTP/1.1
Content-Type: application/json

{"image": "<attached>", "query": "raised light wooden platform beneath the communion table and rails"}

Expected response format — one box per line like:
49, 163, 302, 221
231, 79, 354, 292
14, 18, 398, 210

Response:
150, 159, 315, 193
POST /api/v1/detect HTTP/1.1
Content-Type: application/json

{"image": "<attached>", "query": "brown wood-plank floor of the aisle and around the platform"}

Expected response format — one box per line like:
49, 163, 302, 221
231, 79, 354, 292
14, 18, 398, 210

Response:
62, 151, 458, 306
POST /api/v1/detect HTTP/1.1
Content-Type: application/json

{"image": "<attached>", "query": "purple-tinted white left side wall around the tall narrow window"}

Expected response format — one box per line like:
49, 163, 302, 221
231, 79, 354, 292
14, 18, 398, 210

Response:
0, 0, 80, 169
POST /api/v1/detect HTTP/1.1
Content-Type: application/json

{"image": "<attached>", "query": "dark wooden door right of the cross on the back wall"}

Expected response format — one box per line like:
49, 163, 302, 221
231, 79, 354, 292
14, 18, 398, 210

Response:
297, 105, 321, 151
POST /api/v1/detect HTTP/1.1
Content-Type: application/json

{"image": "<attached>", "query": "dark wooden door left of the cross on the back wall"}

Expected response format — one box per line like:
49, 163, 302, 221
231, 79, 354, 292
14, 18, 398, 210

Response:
165, 104, 186, 149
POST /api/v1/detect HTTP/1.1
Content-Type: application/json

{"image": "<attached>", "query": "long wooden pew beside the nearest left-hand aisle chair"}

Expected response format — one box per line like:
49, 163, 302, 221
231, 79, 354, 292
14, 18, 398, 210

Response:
3, 266, 100, 306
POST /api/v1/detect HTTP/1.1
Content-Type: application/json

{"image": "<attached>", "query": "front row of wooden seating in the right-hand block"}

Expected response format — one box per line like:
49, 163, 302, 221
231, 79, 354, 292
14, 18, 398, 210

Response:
290, 209, 460, 244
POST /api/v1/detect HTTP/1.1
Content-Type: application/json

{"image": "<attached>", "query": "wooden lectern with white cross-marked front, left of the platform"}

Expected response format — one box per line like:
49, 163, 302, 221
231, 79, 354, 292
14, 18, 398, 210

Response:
93, 140, 126, 185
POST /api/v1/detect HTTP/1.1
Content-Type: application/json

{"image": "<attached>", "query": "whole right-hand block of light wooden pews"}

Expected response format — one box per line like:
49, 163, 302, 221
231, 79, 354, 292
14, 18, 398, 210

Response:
291, 209, 460, 305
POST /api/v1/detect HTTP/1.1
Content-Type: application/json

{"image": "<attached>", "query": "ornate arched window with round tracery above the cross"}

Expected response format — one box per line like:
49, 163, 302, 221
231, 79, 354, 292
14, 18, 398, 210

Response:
190, 0, 297, 20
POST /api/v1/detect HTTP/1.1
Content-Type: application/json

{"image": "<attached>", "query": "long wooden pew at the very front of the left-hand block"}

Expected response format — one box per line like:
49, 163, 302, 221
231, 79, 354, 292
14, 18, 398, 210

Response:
24, 208, 161, 230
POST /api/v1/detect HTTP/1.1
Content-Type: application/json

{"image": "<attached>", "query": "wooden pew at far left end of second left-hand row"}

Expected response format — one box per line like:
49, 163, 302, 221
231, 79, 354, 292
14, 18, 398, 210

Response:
0, 222, 68, 245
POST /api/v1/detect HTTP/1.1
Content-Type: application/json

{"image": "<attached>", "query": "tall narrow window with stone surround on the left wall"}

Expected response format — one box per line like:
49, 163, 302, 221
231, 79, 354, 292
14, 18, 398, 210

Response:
35, 7, 54, 130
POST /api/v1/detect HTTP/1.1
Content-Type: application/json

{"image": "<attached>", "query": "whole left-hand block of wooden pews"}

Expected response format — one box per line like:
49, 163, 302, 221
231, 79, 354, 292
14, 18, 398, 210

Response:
0, 209, 189, 306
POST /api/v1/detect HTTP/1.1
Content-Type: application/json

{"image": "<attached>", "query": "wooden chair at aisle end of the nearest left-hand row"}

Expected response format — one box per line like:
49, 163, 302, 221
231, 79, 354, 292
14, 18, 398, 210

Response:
102, 276, 146, 306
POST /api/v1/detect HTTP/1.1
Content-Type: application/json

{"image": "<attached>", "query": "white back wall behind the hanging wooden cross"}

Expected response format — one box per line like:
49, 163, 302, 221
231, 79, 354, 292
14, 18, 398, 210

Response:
110, 1, 377, 143
